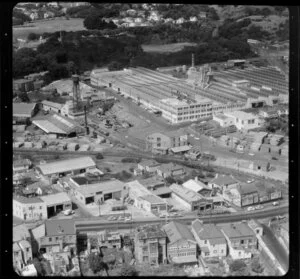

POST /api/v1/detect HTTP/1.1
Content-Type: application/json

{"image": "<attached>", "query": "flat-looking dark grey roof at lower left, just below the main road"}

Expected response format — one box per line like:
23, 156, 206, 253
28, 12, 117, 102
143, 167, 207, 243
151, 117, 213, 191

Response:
45, 219, 76, 236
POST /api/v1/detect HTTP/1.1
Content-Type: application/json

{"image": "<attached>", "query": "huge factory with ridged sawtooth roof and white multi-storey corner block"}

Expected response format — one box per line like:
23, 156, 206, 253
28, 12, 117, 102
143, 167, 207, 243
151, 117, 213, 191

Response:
91, 62, 288, 124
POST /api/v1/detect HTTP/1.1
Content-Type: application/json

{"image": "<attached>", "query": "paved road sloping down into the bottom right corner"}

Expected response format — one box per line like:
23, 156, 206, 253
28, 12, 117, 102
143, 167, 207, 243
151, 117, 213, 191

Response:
262, 224, 289, 271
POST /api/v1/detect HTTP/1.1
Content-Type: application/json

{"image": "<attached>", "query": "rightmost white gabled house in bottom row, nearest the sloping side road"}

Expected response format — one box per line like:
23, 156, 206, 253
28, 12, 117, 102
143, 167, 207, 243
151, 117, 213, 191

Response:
218, 222, 257, 260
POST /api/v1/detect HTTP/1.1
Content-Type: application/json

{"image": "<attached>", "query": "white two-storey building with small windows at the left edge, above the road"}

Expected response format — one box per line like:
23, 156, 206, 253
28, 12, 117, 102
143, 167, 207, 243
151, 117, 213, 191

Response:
13, 196, 48, 221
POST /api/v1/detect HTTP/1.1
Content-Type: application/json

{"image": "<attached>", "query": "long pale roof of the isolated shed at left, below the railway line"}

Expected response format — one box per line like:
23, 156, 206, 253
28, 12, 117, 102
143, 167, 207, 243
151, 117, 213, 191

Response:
37, 157, 96, 175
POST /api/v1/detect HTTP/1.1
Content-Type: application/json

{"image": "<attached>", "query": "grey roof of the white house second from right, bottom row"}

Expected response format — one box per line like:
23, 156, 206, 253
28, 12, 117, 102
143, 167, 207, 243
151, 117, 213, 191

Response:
192, 219, 226, 243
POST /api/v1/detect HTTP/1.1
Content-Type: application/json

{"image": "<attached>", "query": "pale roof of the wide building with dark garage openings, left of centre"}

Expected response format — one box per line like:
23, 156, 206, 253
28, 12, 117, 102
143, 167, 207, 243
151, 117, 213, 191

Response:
76, 179, 125, 196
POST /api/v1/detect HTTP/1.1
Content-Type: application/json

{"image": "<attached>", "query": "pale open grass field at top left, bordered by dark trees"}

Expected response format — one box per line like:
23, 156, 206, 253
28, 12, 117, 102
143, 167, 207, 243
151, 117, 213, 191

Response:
13, 18, 85, 39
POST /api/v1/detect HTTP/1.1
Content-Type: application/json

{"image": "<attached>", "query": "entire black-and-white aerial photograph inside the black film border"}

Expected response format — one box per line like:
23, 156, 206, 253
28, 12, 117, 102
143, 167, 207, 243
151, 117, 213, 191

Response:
12, 2, 290, 277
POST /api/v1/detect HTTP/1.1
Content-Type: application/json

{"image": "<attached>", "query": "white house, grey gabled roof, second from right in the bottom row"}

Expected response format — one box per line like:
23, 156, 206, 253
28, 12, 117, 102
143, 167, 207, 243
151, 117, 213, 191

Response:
191, 219, 227, 259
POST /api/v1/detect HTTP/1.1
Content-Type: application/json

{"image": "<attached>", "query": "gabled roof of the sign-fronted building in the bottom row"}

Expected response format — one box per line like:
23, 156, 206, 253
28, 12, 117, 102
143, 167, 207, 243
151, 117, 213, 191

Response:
163, 221, 196, 244
